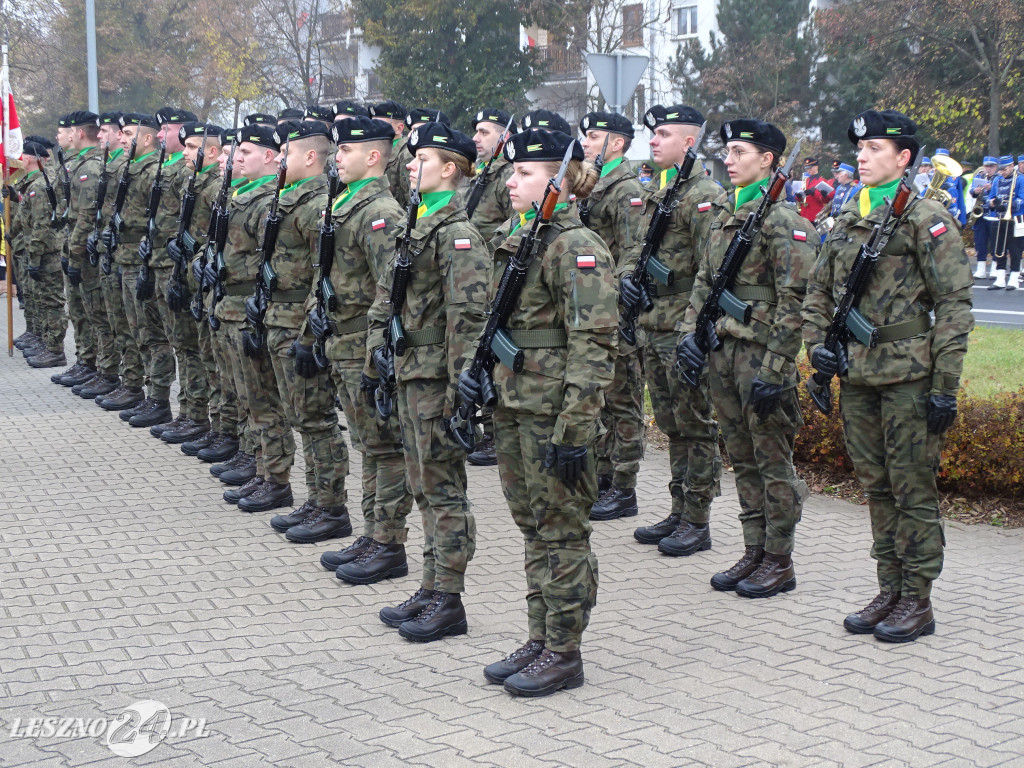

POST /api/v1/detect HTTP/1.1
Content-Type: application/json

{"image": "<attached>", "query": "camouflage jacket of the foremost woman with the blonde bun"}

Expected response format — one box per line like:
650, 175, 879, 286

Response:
492, 205, 618, 445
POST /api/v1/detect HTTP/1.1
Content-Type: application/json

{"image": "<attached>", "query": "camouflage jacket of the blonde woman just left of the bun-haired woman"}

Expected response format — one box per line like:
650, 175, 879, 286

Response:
367, 196, 490, 412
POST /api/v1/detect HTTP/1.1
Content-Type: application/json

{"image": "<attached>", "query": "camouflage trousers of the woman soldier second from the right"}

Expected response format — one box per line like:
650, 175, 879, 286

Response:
708, 336, 807, 555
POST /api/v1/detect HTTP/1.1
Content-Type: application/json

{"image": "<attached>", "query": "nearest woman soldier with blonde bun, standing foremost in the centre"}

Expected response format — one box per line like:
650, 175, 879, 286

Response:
460, 130, 618, 696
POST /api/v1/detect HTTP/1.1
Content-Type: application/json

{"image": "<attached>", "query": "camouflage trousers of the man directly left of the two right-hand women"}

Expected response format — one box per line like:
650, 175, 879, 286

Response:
643, 331, 722, 525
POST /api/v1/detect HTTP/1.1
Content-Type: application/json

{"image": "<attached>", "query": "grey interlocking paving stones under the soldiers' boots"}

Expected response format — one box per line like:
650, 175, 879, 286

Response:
0, 309, 1024, 768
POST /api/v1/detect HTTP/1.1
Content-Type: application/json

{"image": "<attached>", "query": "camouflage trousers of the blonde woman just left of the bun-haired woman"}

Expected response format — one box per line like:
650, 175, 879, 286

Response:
392, 379, 476, 592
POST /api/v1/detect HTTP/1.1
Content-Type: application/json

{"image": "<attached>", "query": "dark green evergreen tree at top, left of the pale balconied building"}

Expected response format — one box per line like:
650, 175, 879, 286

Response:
352, 0, 540, 129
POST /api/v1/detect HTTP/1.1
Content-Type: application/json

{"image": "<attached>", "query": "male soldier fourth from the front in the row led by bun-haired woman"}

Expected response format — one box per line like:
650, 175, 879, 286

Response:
239, 122, 352, 544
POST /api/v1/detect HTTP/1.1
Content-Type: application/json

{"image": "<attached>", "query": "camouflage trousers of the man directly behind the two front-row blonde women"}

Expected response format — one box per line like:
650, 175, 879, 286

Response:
328, 354, 413, 544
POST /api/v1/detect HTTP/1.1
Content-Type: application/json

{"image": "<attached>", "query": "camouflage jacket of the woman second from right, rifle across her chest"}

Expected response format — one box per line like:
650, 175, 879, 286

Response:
680, 195, 817, 384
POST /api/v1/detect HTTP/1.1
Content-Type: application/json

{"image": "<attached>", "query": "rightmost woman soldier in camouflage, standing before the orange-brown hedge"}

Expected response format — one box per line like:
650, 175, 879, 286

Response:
803, 111, 974, 642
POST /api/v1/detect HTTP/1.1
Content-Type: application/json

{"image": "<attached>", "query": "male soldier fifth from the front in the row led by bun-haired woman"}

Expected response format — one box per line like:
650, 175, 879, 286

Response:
215, 125, 295, 512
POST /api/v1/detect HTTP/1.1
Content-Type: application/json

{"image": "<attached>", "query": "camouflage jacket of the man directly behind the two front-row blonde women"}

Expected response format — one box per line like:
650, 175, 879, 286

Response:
306, 178, 404, 360
